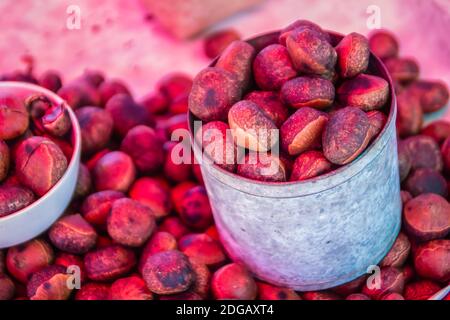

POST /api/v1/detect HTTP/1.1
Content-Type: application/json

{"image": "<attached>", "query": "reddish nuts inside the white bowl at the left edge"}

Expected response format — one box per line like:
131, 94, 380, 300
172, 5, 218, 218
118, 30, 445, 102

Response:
0, 93, 73, 219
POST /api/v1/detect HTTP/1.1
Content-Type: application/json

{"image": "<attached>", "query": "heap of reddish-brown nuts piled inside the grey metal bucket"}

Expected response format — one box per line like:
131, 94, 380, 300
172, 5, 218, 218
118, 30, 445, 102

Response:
189, 20, 389, 182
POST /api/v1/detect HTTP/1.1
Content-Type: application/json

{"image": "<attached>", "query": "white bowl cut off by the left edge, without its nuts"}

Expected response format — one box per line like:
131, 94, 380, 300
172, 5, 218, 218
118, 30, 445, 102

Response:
0, 81, 81, 249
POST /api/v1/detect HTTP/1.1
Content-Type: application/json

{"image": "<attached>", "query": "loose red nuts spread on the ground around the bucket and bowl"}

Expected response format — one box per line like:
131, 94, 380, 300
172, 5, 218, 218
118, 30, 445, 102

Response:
0, 20, 450, 300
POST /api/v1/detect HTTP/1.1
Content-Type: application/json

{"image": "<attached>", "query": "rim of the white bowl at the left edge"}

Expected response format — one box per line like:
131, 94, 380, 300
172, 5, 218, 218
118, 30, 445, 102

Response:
0, 81, 81, 224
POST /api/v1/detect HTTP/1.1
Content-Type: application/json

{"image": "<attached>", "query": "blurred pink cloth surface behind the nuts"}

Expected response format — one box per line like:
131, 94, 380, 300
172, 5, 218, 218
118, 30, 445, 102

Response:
0, 0, 450, 118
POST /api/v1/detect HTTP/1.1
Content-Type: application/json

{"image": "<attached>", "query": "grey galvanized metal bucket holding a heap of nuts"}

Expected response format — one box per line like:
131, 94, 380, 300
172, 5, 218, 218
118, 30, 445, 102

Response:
189, 33, 401, 291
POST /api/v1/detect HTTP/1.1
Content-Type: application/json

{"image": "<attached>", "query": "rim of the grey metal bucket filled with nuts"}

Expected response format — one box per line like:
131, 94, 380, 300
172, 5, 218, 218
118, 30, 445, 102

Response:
188, 30, 397, 198
